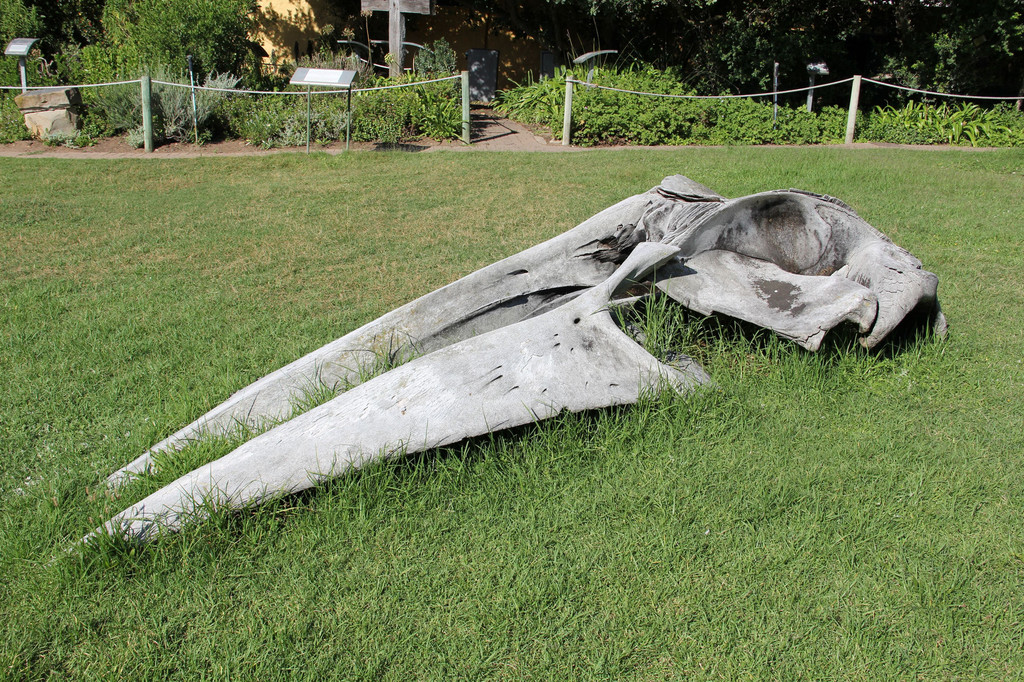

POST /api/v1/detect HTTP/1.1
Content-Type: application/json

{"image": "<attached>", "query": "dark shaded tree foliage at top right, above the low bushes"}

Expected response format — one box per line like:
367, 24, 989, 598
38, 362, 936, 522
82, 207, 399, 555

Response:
444, 0, 1024, 105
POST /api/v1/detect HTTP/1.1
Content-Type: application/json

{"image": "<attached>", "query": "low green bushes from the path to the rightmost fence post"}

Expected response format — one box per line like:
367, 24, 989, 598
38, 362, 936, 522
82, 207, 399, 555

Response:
496, 67, 846, 145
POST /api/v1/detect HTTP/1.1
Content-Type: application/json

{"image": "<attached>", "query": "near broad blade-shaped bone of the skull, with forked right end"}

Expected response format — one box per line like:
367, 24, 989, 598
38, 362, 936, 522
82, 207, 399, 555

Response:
92, 244, 708, 541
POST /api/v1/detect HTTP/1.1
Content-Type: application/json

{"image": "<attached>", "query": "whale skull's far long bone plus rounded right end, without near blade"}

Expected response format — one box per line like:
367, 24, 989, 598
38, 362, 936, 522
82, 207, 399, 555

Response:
109, 175, 945, 484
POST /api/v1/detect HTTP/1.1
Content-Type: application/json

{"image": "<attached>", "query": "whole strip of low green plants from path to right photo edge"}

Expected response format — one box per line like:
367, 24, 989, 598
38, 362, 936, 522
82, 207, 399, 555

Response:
496, 67, 1024, 146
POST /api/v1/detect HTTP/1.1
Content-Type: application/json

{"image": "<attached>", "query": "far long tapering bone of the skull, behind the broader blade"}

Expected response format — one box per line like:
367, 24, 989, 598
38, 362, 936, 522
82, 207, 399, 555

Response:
108, 195, 648, 485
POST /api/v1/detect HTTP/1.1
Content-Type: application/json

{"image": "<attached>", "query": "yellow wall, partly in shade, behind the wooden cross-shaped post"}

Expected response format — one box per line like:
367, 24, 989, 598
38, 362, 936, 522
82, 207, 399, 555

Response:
257, 0, 542, 88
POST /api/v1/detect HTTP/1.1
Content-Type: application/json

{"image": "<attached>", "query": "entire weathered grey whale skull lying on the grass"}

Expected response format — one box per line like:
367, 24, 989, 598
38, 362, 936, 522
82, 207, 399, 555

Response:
92, 175, 946, 541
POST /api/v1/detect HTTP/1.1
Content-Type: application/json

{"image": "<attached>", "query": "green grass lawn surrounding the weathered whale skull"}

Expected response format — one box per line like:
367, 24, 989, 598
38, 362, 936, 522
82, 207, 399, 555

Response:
0, 147, 1024, 680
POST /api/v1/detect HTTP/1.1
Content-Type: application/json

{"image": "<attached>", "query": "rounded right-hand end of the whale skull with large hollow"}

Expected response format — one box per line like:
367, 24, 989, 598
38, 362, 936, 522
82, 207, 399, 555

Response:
666, 189, 946, 349
